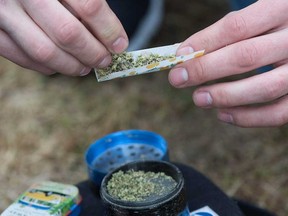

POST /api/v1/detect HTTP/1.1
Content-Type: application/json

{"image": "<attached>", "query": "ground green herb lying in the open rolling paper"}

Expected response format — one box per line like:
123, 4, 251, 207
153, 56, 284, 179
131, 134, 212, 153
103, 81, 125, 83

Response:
97, 52, 175, 76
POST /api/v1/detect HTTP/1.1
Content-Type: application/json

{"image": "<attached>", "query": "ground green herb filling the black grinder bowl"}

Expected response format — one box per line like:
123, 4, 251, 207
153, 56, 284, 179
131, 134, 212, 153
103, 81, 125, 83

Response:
107, 170, 177, 202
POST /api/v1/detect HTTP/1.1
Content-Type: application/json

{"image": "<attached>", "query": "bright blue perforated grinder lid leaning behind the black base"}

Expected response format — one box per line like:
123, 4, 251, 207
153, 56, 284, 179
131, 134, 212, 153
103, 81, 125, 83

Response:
85, 130, 169, 186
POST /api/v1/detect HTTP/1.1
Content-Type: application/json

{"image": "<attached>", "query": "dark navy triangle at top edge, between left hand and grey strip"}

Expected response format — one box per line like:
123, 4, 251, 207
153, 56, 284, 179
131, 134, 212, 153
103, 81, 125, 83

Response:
107, 0, 149, 38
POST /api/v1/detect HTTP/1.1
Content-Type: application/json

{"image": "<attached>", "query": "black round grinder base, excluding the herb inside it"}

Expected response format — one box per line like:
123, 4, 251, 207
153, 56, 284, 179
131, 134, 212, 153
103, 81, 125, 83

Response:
100, 161, 189, 216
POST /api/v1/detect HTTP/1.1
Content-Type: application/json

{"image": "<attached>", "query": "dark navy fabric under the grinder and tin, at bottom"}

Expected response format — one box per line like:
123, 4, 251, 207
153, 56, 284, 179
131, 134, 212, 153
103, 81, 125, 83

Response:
77, 164, 243, 216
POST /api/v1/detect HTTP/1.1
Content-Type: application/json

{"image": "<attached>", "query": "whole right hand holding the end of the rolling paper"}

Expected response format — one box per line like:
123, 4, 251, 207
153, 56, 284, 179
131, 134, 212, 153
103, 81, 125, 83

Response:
169, 0, 288, 127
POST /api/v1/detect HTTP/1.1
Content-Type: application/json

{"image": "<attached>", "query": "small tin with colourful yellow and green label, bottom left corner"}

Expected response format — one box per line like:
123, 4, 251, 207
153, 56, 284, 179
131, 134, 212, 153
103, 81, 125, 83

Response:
1, 181, 81, 216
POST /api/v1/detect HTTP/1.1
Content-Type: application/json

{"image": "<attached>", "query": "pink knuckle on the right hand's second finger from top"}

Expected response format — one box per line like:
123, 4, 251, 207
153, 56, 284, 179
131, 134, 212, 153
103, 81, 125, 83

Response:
236, 41, 258, 68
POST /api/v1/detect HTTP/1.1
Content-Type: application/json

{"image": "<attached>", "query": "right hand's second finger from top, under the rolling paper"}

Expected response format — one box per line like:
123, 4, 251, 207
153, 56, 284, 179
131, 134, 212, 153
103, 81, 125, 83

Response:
169, 30, 288, 88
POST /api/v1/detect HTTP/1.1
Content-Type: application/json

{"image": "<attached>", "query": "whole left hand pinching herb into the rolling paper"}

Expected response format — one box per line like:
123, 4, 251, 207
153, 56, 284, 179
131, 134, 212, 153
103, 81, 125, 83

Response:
0, 0, 128, 76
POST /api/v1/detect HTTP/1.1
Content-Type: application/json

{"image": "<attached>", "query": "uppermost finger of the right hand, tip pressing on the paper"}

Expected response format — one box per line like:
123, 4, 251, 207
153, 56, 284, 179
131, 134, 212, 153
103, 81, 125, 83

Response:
178, 0, 288, 54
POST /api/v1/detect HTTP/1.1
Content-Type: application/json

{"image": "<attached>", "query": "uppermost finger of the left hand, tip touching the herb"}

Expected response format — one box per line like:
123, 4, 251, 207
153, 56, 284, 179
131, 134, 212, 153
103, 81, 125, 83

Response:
65, 0, 128, 53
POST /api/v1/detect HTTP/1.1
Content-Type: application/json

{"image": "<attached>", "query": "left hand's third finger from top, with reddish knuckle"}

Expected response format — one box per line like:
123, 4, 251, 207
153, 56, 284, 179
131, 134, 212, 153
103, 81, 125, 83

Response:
3, 2, 90, 76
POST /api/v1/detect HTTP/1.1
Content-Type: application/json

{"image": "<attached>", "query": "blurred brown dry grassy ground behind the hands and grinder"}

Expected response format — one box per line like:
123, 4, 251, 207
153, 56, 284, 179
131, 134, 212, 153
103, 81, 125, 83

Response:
0, 0, 288, 216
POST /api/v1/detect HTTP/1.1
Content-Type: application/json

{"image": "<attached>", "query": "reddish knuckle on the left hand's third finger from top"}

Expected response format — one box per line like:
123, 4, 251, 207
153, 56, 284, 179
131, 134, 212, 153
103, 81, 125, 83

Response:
32, 43, 56, 63
